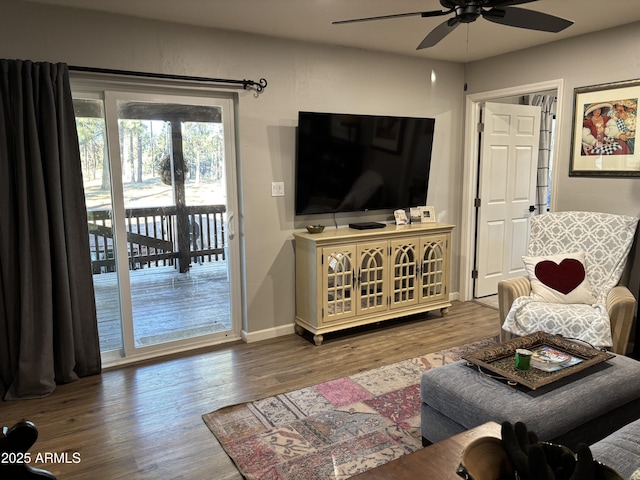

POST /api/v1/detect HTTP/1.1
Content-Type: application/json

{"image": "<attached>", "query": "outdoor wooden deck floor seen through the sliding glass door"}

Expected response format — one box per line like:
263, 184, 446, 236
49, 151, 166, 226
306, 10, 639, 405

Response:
93, 261, 231, 352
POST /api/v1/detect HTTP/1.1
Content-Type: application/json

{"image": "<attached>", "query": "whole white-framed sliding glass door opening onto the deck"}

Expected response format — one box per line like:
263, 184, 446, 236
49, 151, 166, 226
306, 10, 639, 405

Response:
74, 83, 239, 365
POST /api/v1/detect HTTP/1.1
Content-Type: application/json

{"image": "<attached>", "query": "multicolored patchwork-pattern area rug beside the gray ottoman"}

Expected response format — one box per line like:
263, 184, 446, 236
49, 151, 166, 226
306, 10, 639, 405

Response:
202, 337, 497, 480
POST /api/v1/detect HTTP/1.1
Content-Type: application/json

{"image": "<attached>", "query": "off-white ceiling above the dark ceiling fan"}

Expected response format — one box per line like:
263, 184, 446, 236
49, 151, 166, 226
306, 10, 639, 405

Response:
22, 0, 640, 62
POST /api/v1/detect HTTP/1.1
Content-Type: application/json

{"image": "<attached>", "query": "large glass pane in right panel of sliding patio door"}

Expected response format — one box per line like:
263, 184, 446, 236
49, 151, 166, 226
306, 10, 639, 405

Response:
117, 99, 231, 348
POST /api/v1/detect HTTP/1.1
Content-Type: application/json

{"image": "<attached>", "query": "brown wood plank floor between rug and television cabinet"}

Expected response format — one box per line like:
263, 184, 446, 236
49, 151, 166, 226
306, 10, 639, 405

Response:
0, 302, 499, 480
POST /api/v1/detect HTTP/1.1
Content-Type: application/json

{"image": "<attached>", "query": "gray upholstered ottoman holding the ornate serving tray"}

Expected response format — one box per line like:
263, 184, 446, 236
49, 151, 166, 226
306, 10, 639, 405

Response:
420, 355, 640, 448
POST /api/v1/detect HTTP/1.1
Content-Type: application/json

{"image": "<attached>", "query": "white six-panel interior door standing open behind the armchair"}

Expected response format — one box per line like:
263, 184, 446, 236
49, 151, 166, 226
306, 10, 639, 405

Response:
474, 103, 540, 297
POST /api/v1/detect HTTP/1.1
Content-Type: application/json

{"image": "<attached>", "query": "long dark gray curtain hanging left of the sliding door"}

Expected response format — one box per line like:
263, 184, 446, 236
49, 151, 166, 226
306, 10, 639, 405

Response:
0, 60, 101, 400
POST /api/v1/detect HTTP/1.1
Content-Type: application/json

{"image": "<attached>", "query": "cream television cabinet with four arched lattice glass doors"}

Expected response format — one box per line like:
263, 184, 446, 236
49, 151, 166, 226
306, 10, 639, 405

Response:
293, 223, 454, 345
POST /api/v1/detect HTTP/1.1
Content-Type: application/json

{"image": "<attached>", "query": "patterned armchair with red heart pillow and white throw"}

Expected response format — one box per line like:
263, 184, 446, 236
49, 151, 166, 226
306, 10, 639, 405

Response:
498, 212, 638, 355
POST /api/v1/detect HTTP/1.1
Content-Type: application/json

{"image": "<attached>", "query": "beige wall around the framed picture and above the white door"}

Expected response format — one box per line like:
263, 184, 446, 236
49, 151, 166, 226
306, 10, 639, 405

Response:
468, 23, 640, 216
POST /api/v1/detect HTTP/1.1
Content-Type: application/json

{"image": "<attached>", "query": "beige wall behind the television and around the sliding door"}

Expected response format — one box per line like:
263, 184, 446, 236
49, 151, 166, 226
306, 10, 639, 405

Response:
0, 0, 463, 339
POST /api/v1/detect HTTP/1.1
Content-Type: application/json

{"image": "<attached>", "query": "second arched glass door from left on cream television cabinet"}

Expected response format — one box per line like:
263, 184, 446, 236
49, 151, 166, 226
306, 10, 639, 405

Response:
358, 242, 388, 314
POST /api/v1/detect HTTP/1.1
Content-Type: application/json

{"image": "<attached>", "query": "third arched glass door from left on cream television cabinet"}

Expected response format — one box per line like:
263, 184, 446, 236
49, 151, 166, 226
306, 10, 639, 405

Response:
391, 239, 419, 307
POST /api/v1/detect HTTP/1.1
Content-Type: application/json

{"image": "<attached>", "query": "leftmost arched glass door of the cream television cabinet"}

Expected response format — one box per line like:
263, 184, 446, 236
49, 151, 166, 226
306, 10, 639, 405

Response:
323, 246, 355, 321
